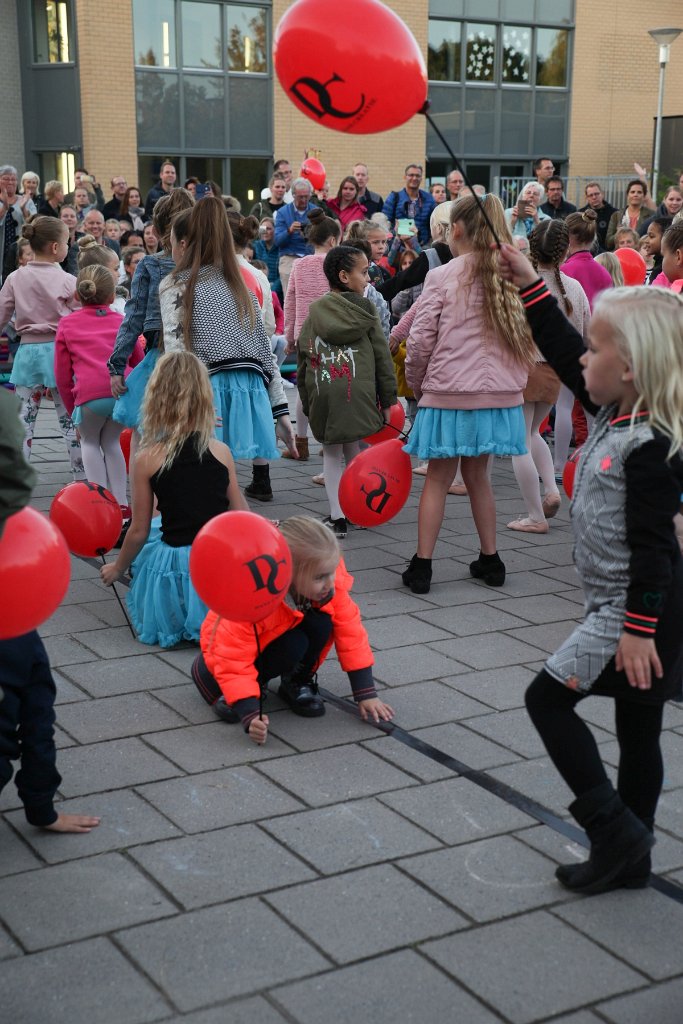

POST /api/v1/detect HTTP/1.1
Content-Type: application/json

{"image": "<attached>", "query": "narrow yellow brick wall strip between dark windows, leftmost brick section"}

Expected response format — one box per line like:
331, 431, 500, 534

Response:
76, 0, 139, 193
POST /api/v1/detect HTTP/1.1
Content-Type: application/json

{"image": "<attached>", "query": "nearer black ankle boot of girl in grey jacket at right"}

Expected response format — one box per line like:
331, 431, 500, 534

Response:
555, 782, 654, 895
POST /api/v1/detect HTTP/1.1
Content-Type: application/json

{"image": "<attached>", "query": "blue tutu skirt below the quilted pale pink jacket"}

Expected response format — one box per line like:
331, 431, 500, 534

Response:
405, 406, 526, 459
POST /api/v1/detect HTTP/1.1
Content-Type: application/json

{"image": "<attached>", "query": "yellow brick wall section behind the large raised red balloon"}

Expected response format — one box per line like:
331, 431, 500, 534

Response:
272, 0, 427, 197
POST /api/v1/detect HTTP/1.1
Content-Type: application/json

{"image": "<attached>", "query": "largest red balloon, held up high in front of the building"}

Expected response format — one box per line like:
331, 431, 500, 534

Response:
273, 0, 427, 135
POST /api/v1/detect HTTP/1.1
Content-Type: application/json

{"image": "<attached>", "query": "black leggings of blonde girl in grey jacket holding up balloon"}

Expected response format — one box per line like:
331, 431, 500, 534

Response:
525, 669, 664, 827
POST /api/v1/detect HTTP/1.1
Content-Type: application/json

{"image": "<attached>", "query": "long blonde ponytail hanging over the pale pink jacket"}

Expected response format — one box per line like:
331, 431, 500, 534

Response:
451, 194, 536, 367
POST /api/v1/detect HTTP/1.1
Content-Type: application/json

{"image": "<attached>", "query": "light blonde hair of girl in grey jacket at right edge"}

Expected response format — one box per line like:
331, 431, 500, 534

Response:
593, 287, 683, 459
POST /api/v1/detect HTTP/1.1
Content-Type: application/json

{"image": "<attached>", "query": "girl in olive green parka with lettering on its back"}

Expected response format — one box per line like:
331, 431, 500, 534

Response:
297, 246, 397, 537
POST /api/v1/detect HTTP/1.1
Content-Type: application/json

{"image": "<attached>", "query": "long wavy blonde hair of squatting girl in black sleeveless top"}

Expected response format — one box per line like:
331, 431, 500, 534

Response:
139, 351, 216, 470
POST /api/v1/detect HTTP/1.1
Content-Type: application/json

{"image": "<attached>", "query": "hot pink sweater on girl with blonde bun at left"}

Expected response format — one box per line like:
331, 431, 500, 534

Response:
54, 303, 144, 416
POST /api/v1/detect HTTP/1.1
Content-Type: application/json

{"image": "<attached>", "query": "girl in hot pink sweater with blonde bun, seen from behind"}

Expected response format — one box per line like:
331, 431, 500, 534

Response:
54, 264, 143, 518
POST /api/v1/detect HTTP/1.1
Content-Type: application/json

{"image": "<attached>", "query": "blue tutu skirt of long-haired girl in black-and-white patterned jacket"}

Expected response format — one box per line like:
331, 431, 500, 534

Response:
211, 370, 280, 459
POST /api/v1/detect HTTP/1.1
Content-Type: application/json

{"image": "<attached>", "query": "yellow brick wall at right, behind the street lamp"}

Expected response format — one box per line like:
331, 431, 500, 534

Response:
569, 0, 683, 174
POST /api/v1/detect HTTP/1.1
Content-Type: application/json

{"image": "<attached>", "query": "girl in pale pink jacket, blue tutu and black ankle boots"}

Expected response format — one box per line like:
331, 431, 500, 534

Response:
402, 196, 535, 594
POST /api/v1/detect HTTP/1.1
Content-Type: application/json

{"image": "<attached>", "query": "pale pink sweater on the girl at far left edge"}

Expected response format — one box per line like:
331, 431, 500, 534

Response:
0, 260, 80, 345
